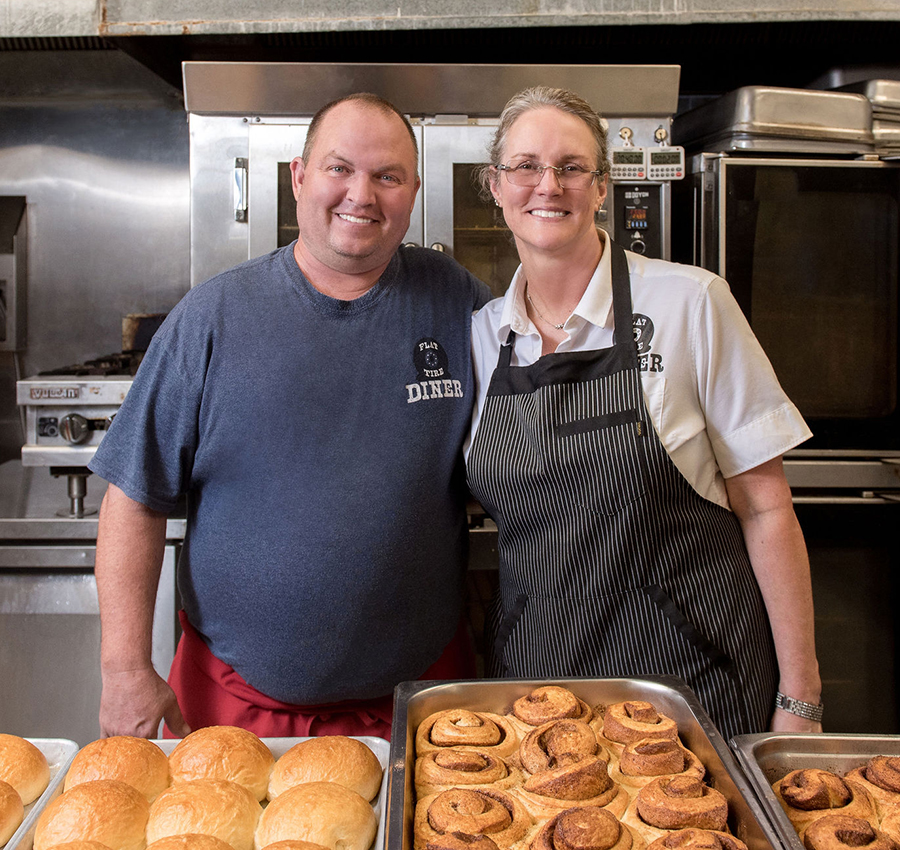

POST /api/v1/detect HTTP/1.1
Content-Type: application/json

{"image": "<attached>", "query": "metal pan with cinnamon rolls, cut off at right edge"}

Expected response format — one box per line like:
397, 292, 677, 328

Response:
732, 733, 900, 850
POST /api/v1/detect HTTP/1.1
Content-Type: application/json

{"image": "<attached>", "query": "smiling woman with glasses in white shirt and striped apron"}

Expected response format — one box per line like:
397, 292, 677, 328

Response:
466, 87, 821, 740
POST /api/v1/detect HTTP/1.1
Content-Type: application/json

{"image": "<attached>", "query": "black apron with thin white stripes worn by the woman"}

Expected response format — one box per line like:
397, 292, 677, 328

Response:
468, 240, 778, 740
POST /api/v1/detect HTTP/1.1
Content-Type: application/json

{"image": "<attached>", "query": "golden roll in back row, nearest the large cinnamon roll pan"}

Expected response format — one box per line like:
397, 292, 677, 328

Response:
269, 735, 381, 800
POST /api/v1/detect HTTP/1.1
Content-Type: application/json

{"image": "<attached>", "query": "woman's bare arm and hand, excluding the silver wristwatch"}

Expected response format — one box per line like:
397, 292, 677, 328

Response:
725, 456, 822, 732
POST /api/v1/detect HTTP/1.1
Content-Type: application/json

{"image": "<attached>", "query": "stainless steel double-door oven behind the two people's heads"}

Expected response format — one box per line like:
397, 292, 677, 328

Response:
184, 62, 680, 295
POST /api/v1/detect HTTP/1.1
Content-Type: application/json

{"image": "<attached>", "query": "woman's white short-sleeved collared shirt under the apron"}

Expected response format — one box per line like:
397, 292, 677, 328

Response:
465, 232, 811, 507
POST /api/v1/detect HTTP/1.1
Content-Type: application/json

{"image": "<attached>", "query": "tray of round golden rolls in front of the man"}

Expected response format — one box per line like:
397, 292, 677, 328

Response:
10, 726, 390, 850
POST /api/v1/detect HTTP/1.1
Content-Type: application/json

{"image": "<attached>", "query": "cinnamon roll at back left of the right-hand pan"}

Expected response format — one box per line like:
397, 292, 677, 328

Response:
772, 767, 876, 839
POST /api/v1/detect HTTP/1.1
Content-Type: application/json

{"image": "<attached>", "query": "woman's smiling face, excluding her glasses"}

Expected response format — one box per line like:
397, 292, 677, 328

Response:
491, 106, 606, 264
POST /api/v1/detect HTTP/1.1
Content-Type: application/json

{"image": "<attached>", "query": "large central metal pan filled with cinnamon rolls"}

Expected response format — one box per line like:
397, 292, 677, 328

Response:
385, 676, 781, 850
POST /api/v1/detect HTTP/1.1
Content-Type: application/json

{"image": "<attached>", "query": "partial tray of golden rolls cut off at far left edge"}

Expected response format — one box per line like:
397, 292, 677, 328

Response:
0, 733, 78, 850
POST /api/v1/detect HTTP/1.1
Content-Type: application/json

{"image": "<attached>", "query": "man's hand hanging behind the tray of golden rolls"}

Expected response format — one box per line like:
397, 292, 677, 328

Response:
100, 667, 191, 738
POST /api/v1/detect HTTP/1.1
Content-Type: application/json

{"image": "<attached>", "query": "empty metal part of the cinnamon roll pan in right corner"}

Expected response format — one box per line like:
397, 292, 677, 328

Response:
731, 732, 900, 850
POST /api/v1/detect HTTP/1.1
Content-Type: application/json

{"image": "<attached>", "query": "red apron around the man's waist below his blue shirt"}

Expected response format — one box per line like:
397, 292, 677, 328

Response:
170, 611, 475, 741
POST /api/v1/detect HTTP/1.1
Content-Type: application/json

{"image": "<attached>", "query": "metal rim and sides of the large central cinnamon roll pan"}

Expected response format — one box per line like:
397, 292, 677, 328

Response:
385, 676, 781, 850
